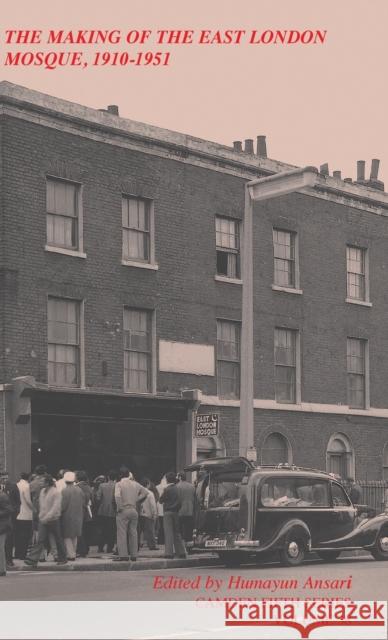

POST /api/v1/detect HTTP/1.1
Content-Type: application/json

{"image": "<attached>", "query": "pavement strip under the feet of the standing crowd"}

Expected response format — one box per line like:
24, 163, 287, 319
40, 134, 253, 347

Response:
8, 546, 370, 573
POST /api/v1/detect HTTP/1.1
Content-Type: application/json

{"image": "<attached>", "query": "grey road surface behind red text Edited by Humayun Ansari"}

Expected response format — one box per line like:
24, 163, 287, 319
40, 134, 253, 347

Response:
0, 557, 388, 601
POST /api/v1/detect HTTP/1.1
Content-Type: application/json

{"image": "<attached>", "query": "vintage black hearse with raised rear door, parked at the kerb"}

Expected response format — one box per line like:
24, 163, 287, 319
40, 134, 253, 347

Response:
187, 457, 388, 566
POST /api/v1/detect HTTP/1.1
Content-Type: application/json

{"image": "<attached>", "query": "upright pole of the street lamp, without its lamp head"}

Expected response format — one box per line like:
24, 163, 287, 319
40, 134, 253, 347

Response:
239, 186, 254, 456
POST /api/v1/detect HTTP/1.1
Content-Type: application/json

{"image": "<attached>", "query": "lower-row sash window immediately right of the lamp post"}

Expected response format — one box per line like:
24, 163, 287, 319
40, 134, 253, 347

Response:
274, 329, 298, 404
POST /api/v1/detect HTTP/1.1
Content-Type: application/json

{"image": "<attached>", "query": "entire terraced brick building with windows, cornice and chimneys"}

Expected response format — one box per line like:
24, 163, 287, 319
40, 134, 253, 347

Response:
0, 82, 388, 479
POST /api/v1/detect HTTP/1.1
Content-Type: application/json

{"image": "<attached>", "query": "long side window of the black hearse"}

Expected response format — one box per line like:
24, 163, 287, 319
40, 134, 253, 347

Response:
261, 478, 329, 507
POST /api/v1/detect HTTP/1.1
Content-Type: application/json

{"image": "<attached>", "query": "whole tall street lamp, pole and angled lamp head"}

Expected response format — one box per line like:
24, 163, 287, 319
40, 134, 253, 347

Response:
239, 167, 319, 456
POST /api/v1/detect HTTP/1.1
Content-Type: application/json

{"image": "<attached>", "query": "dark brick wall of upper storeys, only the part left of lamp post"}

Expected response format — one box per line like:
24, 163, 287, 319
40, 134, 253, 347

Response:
2, 118, 244, 393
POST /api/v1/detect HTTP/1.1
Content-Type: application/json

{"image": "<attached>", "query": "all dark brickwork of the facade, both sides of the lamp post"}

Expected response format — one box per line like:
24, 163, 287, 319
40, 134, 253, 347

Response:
1, 111, 388, 477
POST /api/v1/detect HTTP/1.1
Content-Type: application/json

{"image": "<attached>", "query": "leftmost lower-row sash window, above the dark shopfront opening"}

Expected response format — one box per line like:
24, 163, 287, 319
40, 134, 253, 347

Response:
47, 298, 81, 387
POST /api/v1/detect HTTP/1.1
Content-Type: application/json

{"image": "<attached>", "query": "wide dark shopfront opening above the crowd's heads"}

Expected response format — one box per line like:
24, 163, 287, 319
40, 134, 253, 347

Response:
32, 415, 177, 482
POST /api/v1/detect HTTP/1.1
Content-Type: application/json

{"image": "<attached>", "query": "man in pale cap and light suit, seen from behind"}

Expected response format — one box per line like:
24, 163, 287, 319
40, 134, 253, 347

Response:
61, 471, 84, 560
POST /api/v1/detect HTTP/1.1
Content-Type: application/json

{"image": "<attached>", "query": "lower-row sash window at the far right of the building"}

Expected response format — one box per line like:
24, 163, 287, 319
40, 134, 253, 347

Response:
347, 338, 366, 409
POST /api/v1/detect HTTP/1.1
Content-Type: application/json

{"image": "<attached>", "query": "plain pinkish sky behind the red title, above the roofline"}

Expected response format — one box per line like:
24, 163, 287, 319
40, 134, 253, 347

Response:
1, 0, 388, 179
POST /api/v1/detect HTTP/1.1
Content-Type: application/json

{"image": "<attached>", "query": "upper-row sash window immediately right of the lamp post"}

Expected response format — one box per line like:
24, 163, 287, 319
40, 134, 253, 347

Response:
273, 229, 298, 289
